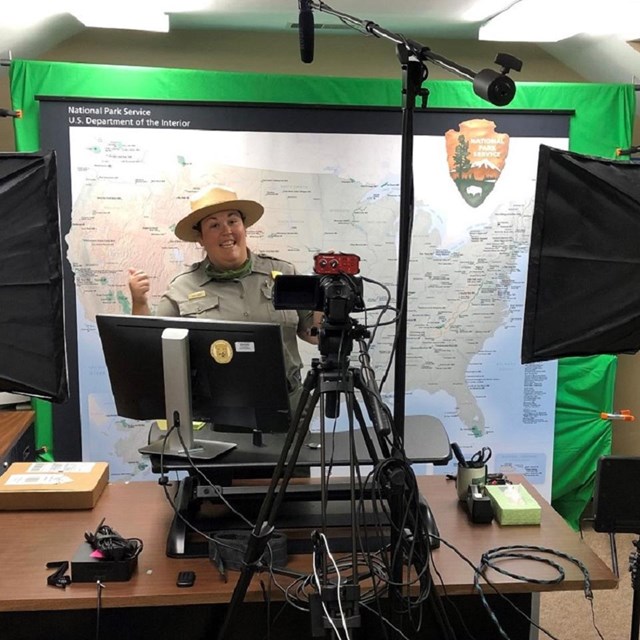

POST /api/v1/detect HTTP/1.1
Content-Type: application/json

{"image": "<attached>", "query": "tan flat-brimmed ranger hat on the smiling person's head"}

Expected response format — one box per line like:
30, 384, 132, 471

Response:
175, 187, 264, 242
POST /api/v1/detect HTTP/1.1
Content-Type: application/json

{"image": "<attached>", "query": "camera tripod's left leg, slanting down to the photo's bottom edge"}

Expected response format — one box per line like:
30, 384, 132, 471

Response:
218, 367, 319, 640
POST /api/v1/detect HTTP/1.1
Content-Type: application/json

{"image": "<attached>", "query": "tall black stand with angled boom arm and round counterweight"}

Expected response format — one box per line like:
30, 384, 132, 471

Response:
307, 0, 522, 437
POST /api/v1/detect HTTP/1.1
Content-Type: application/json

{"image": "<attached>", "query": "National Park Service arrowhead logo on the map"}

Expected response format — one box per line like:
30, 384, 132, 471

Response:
444, 118, 509, 208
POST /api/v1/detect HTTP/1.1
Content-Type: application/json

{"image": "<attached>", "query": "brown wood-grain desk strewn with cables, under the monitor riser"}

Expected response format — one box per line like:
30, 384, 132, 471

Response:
0, 476, 617, 640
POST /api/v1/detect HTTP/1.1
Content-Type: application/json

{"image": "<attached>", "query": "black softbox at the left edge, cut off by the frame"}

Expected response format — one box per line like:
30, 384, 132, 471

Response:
0, 152, 68, 402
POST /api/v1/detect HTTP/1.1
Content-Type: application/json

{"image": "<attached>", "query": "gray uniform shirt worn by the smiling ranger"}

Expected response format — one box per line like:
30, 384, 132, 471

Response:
155, 254, 313, 393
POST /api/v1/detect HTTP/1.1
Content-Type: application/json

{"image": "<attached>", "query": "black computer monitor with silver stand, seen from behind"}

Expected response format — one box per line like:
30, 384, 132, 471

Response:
96, 314, 290, 459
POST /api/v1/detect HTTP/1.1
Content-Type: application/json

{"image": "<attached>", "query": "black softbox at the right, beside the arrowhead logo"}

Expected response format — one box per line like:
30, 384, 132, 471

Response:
522, 145, 640, 363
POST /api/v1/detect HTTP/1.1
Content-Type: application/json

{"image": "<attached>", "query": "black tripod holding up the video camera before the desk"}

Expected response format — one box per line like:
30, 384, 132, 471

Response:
218, 319, 442, 640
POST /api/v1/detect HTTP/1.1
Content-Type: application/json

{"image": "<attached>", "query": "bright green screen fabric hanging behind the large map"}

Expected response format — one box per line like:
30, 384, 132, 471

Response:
9, 58, 636, 527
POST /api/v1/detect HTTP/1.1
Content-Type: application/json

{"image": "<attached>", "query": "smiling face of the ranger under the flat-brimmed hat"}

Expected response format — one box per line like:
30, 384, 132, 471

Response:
199, 210, 249, 271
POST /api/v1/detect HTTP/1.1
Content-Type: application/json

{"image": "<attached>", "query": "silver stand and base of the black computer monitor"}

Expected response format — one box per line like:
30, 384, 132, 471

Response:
139, 328, 236, 460
